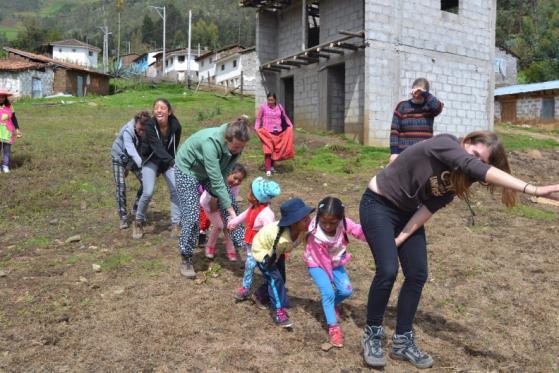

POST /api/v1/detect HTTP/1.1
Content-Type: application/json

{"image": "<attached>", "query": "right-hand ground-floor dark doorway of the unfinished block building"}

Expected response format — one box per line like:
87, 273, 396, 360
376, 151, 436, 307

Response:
326, 64, 345, 133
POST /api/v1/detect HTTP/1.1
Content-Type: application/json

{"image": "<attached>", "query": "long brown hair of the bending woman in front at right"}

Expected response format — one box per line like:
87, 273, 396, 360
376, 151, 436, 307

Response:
450, 131, 517, 208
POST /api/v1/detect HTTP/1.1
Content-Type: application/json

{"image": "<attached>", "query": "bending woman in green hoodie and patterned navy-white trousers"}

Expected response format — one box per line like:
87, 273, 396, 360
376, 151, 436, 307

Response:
175, 117, 250, 278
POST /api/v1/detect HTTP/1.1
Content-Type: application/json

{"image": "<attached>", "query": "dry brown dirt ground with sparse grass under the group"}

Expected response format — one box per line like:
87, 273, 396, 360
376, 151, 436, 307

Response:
0, 132, 559, 372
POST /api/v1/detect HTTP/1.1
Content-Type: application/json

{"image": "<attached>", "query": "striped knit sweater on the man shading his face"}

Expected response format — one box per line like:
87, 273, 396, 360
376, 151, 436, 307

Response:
390, 92, 443, 154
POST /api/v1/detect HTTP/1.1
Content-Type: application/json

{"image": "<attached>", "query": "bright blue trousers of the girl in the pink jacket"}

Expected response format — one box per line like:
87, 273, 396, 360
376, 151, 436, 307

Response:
308, 266, 353, 325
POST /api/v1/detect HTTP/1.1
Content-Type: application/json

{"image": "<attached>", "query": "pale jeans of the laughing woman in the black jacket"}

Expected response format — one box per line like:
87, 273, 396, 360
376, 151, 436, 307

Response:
136, 162, 180, 224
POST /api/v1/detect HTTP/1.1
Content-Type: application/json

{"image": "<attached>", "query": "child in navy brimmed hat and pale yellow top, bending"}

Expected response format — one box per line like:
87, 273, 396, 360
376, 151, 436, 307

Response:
252, 198, 314, 328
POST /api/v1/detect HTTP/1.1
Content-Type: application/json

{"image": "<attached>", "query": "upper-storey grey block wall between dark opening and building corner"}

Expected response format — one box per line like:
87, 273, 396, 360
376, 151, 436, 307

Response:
320, 0, 365, 43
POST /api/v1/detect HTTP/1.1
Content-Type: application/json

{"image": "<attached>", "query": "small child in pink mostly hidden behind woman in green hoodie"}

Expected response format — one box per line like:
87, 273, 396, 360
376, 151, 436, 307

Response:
200, 163, 247, 262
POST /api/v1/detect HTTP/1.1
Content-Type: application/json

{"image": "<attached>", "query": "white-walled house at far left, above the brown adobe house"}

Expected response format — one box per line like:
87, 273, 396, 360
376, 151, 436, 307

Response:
43, 39, 101, 68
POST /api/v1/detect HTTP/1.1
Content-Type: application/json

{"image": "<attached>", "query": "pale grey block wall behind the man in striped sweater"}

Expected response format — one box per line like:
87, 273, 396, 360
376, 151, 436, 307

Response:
364, 0, 496, 146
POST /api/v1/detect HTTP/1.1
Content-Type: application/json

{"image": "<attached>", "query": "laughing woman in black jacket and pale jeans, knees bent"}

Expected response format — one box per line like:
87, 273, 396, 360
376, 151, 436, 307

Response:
132, 98, 182, 239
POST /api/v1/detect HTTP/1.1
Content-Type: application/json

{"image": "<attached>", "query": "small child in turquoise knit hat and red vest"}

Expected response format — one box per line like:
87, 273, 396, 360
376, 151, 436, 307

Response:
227, 177, 281, 301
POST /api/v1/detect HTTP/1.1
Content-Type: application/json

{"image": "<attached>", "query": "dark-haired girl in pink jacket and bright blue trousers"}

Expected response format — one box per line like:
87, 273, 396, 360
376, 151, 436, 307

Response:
303, 197, 365, 347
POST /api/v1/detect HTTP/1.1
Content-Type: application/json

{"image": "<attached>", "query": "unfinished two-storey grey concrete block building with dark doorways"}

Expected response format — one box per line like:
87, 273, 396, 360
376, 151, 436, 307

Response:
241, 0, 496, 146
